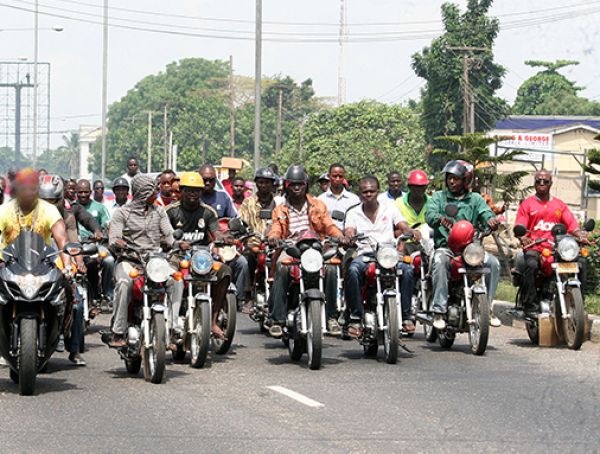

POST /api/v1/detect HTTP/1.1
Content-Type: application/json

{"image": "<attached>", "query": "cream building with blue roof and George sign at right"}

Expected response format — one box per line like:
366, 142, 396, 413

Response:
489, 115, 600, 218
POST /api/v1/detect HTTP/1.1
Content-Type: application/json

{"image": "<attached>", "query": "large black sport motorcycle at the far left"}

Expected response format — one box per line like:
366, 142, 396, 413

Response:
0, 230, 95, 395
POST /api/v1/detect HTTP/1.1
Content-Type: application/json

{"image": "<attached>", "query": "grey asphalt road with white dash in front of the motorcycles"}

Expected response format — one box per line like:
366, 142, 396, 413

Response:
0, 316, 600, 453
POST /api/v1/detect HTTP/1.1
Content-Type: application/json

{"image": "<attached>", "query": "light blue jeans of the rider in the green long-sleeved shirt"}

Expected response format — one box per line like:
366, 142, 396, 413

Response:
431, 248, 500, 314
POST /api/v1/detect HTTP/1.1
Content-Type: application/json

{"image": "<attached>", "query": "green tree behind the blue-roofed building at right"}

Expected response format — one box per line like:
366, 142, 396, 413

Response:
512, 60, 600, 115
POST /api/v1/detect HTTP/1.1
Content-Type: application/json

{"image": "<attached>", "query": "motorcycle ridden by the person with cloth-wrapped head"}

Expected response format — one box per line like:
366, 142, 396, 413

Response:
102, 247, 174, 384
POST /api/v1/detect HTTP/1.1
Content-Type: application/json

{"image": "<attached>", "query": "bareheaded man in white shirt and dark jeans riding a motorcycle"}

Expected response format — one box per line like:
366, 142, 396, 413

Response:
344, 176, 415, 337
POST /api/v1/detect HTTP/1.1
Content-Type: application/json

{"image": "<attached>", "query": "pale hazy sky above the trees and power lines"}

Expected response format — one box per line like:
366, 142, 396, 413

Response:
0, 0, 600, 146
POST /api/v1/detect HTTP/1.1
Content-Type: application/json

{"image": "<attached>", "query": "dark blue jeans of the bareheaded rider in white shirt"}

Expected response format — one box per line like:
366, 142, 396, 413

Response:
345, 256, 415, 320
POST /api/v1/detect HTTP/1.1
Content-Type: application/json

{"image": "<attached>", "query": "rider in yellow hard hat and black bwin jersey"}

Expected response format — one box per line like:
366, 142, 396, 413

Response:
167, 172, 236, 338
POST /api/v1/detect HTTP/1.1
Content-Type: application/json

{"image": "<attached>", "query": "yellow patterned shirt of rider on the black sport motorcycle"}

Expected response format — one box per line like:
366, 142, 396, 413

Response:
0, 199, 62, 250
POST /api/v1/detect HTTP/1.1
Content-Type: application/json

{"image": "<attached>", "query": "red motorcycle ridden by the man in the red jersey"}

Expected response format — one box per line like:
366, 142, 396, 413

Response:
510, 219, 596, 350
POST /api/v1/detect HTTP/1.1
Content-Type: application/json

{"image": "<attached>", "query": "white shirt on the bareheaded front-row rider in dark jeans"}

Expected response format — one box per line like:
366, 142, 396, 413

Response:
346, 203, 405, 255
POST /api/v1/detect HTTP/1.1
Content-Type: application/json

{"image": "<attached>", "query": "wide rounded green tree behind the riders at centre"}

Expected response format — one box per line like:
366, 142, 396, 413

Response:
279, 101, 426, 186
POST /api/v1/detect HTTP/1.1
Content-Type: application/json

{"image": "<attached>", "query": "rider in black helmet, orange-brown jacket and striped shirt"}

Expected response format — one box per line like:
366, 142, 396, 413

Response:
269, 165, 343, 337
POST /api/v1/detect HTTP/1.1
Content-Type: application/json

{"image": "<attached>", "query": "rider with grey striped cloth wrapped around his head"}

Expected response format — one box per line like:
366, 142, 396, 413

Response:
109, 174, 175, 348
